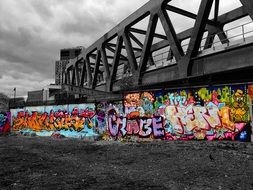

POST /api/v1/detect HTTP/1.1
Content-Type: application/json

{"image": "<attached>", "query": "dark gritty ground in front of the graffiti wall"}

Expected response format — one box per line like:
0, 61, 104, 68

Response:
0, 136, 253, 190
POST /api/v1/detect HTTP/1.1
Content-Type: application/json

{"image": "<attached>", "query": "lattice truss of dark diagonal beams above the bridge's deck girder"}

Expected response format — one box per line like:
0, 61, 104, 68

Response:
64, 0, 253, 92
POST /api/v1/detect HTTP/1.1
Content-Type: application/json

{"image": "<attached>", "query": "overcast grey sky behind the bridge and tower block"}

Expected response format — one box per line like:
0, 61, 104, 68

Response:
0, 0, 245, 97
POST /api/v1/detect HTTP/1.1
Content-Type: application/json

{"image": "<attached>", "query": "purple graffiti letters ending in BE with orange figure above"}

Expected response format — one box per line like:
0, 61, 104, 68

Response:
107, 92, 165, 139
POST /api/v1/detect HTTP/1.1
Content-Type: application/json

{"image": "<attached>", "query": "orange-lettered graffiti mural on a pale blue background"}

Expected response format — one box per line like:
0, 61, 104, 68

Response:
12, 104, 99, 137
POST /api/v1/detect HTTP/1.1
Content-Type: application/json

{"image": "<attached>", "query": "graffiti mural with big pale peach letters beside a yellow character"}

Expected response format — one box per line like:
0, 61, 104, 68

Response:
155, 86, 249, 140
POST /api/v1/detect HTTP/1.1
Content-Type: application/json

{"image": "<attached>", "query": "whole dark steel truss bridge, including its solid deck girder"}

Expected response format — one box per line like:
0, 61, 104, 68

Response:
63, 0, 253, 96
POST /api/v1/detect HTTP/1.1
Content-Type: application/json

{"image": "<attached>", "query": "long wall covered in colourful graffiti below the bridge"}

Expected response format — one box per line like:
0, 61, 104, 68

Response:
11, 85, 251, 141
